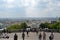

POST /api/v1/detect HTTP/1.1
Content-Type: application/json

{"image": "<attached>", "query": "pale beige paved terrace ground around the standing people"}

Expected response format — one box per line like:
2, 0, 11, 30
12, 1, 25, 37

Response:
0, 32, 60, 40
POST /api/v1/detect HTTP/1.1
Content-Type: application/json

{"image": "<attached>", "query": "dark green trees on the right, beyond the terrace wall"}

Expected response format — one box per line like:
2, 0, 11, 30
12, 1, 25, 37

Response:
39, 22, 60, 29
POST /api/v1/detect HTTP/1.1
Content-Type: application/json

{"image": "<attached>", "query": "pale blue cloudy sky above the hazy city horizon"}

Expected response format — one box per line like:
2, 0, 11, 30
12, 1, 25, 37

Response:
0, 0, 60, 18
